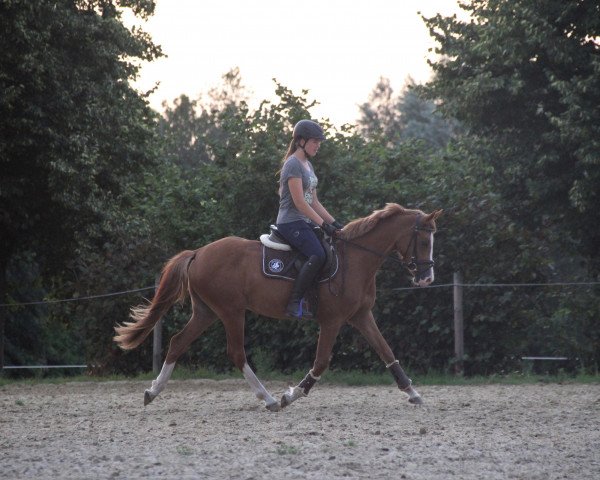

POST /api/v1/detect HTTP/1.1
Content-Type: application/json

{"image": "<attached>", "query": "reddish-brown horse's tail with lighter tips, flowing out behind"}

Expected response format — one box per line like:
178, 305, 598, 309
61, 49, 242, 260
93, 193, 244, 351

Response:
113, 250, 196, 350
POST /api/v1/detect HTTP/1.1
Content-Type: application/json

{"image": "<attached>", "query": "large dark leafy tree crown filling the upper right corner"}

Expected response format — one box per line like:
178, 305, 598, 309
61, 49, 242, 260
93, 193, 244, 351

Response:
423, 0, 600, 278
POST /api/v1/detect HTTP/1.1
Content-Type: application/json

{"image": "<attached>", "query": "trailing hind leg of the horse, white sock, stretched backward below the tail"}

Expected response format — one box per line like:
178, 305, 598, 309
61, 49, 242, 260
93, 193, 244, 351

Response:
144, 299, 217, 405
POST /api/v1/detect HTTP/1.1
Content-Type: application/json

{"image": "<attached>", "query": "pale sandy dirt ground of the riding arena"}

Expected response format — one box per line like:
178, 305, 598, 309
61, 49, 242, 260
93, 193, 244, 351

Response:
0, 380, 600, 480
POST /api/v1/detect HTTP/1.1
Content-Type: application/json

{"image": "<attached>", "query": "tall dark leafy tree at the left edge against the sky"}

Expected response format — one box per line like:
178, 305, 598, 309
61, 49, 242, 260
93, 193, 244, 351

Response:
0, 0, 161, 368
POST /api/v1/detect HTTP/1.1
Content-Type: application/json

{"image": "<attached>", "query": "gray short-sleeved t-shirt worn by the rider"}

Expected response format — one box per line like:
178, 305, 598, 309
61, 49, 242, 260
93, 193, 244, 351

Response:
276, 155, 319, 223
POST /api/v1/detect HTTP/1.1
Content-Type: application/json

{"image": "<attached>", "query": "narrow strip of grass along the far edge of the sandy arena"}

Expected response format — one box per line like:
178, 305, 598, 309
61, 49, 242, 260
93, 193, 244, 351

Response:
0, 367, 600, 387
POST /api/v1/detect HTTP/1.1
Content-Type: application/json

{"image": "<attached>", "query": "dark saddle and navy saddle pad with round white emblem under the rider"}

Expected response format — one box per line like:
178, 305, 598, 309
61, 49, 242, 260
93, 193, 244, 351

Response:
260, 225, 339, 316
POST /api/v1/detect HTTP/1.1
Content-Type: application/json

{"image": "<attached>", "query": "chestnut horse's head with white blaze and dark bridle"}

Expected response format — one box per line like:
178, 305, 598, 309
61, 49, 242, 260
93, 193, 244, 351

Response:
397, 210, 443, 287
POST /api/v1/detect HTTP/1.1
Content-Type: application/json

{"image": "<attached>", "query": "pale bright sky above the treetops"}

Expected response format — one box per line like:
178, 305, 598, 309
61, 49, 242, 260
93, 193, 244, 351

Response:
125, 0, 462, 126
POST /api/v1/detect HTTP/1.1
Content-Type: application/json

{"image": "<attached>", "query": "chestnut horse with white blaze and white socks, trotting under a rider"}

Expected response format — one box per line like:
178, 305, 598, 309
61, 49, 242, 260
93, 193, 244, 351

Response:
114, 204, 442, 411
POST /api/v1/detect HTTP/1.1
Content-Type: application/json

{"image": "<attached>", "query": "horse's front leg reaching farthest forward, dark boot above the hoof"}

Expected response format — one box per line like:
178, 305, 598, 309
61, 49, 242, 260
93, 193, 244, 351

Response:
349, 310, 423, 405
